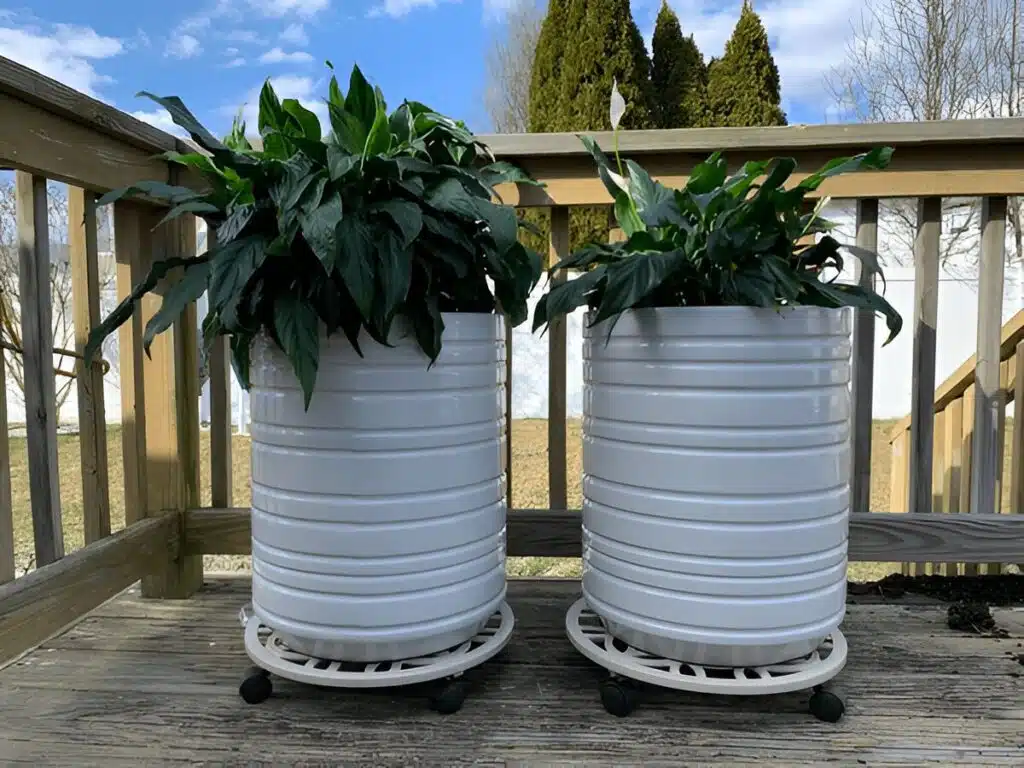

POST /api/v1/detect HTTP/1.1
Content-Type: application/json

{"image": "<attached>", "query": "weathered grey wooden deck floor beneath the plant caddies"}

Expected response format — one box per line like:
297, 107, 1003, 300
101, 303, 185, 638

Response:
0, 577, 1024, 766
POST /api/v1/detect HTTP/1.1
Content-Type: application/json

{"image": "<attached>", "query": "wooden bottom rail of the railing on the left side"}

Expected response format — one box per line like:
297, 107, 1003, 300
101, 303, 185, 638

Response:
0, 515, 179, 667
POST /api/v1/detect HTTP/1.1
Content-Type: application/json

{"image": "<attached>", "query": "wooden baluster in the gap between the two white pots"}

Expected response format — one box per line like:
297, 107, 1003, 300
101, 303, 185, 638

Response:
548, 206, 569, 509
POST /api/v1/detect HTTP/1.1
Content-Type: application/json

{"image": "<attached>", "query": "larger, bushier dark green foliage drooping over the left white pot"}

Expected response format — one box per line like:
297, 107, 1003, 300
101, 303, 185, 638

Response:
86, 68, 542, 408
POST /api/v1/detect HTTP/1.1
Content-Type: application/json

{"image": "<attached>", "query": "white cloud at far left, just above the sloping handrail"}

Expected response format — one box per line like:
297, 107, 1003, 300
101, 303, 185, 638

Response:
0, 20, 124, 98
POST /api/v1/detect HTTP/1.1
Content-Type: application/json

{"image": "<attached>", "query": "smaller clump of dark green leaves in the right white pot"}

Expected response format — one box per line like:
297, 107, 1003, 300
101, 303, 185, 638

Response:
534, 137, 902, 343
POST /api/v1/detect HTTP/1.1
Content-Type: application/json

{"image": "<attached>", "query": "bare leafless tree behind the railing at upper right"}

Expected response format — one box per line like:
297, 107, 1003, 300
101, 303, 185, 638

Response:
825, 0, 1024, 271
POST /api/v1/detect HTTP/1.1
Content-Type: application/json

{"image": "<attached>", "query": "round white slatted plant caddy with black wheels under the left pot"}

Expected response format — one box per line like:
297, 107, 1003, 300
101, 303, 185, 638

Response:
239, 602, 515, 715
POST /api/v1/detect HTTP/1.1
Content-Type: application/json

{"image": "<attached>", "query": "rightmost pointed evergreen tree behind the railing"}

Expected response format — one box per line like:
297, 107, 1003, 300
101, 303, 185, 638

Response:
707, 0, 786, 127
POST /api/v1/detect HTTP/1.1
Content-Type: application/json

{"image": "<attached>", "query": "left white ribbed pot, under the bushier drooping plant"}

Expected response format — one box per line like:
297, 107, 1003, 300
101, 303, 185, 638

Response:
251, 313, 506, 662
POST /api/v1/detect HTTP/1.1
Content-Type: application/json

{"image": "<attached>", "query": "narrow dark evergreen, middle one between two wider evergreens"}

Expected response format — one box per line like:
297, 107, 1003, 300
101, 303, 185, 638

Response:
650, 2, 708, 128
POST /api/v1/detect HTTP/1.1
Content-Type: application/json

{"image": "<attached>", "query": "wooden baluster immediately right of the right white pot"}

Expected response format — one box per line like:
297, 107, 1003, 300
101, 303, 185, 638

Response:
850, 199, 879, 518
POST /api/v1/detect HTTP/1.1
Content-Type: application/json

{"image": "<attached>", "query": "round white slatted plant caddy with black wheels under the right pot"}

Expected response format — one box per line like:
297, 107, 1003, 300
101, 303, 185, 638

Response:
565, 598, 847, 723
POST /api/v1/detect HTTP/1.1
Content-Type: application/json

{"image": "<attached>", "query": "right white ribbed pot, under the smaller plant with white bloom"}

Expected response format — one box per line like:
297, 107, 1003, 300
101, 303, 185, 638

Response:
583, 307, 851, 667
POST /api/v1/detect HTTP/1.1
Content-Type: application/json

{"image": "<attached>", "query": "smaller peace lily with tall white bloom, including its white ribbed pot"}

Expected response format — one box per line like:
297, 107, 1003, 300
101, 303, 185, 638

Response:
548, 81, 902, 700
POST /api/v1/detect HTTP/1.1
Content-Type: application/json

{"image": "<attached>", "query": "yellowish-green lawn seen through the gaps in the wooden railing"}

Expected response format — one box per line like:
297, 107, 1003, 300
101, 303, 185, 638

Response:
10, 419, 1012, 580
